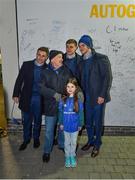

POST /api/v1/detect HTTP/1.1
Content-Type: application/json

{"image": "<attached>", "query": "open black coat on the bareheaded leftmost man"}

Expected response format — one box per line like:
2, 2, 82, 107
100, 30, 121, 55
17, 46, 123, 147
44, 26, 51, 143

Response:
13, 60, 47, 112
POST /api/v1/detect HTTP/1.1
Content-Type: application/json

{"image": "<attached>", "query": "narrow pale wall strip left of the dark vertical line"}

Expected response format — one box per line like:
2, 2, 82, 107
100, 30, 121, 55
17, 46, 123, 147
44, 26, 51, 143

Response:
0, 0, 18, 117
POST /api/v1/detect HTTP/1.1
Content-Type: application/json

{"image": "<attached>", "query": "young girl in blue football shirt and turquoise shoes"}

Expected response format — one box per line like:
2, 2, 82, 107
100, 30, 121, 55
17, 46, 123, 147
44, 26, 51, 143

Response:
59, 78, 84, 167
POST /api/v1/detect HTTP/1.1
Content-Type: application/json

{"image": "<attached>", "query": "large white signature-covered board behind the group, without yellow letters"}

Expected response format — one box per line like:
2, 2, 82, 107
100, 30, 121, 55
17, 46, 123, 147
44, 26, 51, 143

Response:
17, 0, 135, 126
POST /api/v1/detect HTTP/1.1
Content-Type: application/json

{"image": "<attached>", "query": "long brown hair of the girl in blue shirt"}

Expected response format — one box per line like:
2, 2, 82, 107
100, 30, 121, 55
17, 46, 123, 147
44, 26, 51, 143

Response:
62, 78, 79, 112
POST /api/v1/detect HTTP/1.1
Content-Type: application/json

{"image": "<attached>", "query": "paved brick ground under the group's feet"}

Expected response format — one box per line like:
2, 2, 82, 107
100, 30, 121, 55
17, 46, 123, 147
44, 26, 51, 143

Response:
0, 131, 135, 179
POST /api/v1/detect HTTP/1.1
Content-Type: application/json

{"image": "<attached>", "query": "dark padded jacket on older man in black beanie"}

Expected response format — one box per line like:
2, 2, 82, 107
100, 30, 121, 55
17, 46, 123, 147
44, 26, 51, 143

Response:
41, 65, 72, 116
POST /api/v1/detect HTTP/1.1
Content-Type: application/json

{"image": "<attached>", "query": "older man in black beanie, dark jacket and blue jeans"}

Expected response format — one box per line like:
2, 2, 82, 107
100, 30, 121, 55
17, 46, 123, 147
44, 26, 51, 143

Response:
41, 50, 72, 162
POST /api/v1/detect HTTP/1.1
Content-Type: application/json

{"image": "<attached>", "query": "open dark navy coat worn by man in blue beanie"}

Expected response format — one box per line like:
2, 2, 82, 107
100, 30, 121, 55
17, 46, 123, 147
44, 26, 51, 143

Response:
78, 50, 112, 106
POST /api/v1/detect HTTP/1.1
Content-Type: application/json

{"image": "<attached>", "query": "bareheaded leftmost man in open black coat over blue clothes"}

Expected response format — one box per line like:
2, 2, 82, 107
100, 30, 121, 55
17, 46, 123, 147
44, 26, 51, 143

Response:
13, 47, 49, 151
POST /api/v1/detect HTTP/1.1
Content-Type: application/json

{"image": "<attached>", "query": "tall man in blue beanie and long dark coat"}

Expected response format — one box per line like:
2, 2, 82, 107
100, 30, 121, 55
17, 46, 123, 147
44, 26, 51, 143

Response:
78, 35, 112, 157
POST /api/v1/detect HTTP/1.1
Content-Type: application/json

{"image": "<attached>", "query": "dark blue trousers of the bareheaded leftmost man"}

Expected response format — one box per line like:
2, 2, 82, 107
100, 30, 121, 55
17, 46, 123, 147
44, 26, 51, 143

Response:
22, 96, 42, 142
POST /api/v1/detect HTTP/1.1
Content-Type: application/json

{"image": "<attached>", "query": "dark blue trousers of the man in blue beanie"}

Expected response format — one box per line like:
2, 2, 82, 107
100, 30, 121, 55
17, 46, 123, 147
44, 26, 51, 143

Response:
85, 97, 105, 149
